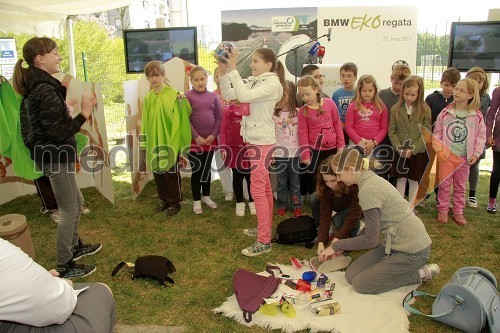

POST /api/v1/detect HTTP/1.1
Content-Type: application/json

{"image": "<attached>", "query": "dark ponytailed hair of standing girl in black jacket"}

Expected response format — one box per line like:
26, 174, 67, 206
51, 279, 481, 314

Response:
12, 37, 57, 95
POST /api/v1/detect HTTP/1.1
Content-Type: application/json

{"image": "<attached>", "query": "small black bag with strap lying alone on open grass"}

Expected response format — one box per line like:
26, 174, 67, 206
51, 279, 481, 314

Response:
111, 255, 175, 287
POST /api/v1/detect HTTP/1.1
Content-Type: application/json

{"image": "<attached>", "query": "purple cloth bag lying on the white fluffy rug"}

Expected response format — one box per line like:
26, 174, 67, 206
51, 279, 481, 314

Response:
233, 266, 281, 323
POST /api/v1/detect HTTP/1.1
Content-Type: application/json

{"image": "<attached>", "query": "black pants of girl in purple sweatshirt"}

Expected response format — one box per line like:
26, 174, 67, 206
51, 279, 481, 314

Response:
188, 150, 214, 201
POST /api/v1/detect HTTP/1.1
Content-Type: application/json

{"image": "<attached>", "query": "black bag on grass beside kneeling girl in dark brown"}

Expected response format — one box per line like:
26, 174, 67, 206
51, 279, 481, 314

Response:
273, 215, 318, 244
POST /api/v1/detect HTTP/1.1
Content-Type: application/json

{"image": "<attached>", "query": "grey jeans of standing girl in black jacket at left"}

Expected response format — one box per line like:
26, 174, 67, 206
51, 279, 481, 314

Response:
36, 163, 83, 265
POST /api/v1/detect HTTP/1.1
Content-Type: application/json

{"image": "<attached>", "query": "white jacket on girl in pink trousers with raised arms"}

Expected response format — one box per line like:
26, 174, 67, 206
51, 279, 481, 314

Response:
219, 70, 283, 145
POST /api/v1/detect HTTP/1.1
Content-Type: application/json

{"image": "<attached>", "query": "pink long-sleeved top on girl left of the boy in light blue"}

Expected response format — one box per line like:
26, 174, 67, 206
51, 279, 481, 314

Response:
299, 98, 345, 161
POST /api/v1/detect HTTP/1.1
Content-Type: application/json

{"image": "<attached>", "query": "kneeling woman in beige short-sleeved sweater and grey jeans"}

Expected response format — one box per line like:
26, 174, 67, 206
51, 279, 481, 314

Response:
320, 149, 439, 294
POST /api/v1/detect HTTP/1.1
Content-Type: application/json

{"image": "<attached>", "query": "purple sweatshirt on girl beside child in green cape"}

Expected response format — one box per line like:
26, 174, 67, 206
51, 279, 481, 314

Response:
186, 89, 222, 140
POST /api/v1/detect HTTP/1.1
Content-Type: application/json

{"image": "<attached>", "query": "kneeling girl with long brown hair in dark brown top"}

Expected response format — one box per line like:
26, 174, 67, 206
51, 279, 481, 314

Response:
310, 156, 363, 255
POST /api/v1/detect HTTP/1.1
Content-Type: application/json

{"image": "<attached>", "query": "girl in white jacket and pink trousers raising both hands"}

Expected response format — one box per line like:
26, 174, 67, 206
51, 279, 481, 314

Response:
219, 48, 286, 257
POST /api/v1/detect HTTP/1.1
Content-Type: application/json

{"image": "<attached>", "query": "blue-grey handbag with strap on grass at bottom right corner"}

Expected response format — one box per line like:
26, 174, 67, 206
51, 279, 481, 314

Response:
403, 267, 500, 333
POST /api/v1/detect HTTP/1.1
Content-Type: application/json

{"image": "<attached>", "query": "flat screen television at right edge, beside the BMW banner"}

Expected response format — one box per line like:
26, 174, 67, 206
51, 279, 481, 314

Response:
448, 21, 500, 72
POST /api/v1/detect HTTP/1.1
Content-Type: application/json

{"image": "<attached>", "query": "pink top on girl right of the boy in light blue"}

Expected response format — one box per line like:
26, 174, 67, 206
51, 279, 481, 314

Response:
345, 101, 389, 144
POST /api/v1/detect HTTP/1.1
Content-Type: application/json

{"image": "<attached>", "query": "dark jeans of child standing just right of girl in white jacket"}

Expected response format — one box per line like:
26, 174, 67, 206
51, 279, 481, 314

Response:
273, 157, 302, 209
